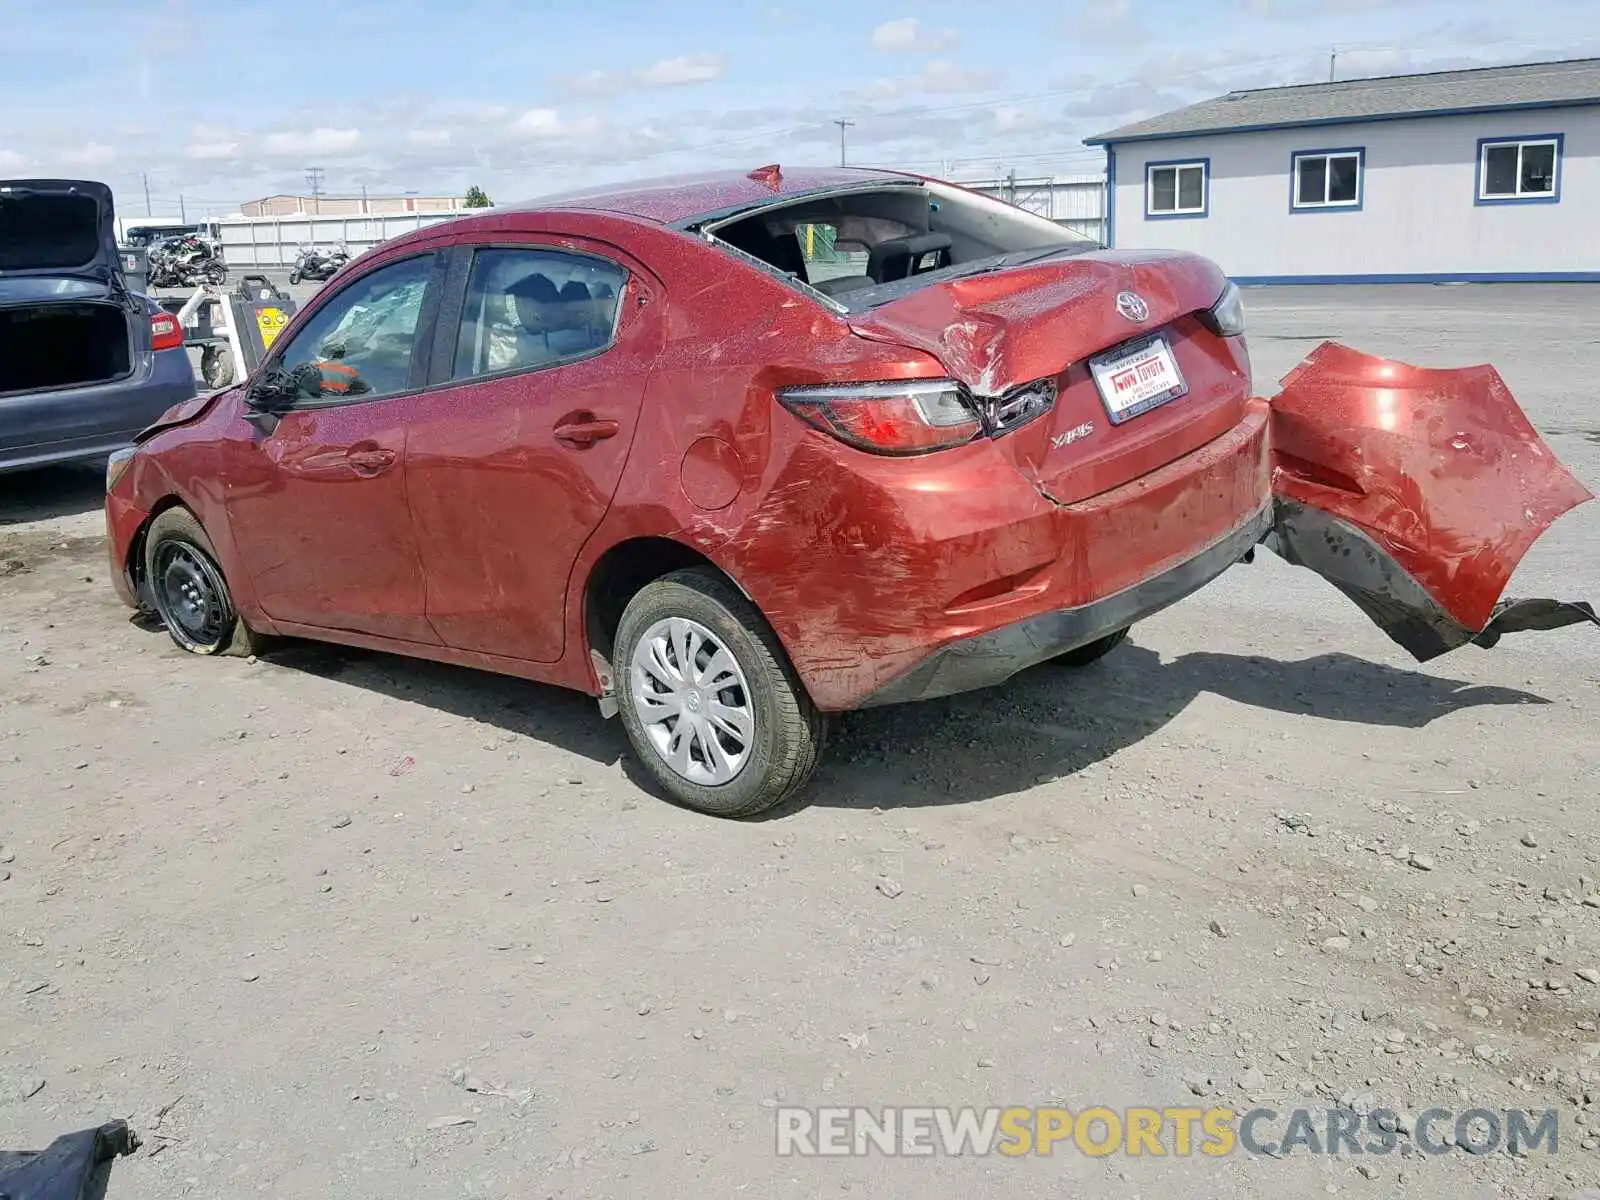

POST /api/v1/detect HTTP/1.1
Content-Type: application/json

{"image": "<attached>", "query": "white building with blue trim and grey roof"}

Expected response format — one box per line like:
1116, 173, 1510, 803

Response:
1086, 59, 1600, 283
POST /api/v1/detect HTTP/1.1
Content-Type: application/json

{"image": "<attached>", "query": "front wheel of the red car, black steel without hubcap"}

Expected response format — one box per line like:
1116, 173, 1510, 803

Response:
144, 509, 264, 654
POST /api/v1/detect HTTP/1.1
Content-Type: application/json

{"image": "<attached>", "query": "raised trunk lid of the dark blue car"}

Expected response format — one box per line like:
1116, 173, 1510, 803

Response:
0, 179, 120, 283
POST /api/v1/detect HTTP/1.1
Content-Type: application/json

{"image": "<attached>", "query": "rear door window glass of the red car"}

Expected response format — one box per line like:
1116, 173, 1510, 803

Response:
453, 248, 627, 379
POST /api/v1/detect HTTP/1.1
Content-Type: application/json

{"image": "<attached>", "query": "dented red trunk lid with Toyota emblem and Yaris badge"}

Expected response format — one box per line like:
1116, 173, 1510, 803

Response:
850, 251, 1250, 504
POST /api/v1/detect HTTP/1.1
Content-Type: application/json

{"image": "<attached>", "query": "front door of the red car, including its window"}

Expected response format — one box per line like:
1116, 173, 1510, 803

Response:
224, 253, 443, 645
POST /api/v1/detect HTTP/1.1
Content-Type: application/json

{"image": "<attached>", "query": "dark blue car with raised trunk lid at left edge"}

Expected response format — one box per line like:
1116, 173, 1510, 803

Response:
0, 179, 195, 470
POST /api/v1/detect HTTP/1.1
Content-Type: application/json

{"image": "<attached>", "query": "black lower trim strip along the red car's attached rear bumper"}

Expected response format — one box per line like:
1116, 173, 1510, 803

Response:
862, 509, 1272, 709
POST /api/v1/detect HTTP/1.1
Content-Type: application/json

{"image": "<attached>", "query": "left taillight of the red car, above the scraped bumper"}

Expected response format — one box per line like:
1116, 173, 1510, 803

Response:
778, 379, 984, 454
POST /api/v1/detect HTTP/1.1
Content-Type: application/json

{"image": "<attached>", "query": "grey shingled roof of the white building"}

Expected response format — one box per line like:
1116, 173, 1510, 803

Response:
1085, 58, 1600, 146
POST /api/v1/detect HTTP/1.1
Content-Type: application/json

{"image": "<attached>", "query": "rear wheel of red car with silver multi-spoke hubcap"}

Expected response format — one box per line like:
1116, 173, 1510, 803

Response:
616, 568, 827, 818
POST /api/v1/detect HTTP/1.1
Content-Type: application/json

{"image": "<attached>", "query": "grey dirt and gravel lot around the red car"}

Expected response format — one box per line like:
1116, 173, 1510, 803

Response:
0, 288, 1600, 1200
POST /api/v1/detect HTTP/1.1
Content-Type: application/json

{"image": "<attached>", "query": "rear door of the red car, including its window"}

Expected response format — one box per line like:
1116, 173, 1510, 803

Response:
406, 235, 661, 662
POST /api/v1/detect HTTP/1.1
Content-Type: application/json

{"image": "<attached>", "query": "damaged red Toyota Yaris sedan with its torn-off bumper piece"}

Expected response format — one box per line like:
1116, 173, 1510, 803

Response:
106, 166, 1594, 816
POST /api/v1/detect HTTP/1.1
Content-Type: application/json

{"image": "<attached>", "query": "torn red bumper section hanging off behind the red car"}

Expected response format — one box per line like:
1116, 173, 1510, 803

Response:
1266, 342, 1600, 662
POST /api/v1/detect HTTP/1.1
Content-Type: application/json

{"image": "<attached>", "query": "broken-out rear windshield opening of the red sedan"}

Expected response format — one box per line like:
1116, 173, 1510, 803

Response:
710, 182, 1099, 309
